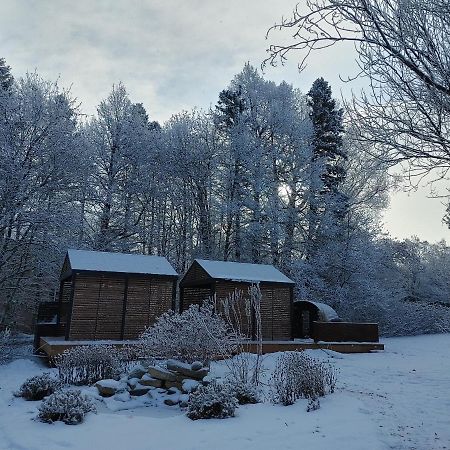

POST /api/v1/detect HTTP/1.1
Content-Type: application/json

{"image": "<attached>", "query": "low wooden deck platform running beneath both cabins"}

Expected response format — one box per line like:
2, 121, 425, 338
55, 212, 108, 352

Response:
39, 337, 384, 358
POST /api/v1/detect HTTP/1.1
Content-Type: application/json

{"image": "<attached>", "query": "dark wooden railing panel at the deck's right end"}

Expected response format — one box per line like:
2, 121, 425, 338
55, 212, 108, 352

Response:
311, 322, 379, 342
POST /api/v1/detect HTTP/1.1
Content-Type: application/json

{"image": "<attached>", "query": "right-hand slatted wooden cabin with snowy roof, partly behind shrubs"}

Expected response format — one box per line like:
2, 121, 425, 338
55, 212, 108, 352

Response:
180, 259, 294, 340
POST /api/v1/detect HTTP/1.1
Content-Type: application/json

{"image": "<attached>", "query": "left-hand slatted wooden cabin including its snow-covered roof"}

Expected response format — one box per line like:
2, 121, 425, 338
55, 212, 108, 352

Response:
37, 250, 178, 342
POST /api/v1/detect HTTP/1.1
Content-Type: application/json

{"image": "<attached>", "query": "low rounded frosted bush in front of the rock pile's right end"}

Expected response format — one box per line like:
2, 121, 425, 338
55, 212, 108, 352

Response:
187, 381, 238, 420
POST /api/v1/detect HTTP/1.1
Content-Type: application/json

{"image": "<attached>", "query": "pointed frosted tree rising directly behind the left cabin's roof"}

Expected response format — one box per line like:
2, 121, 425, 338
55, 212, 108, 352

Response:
86, 83, 156, 251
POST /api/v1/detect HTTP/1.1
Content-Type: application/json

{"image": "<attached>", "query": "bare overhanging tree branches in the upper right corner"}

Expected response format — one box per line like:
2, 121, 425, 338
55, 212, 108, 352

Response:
269, 0, 450, 199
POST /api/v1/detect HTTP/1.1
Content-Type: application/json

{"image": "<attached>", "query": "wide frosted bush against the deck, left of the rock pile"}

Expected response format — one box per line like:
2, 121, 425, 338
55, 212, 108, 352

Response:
55, 345, 123, 385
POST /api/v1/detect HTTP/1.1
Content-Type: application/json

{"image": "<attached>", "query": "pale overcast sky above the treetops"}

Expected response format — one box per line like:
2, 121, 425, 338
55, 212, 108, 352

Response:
0, 0, 450, 242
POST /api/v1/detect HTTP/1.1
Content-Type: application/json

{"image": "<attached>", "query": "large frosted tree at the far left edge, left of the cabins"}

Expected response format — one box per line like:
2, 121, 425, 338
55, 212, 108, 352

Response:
0, 74, 80, 325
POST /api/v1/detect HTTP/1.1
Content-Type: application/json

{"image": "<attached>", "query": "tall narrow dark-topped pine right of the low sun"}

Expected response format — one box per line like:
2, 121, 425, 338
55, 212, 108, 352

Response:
305, 78, 349, 306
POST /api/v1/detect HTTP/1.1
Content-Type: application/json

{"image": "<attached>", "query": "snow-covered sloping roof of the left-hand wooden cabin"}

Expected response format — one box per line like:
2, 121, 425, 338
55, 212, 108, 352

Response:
67, 249, 178, 276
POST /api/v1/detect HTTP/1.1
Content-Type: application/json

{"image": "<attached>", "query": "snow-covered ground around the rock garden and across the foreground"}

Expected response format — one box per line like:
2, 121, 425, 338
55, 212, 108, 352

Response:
0, 334, 450, 450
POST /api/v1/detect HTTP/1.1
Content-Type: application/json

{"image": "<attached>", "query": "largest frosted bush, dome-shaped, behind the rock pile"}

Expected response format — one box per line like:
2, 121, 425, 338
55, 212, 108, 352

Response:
141, 300, 236, 364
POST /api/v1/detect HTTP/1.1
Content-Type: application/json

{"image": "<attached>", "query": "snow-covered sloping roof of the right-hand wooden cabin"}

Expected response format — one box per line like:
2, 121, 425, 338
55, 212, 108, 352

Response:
195, 259, 294, 284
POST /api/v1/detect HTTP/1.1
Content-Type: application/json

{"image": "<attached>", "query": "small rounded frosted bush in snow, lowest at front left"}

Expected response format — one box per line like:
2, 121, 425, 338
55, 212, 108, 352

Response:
37, 390, 96, 425
